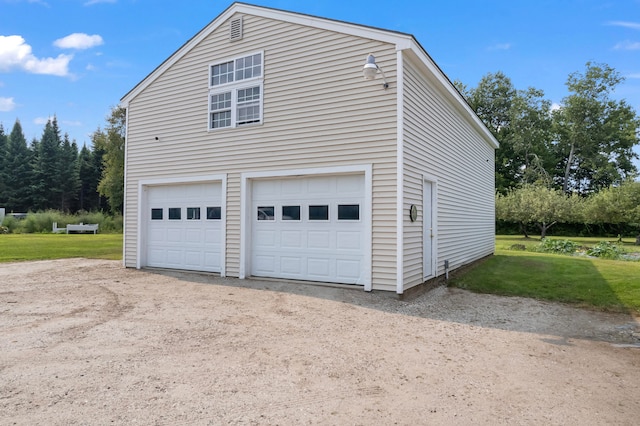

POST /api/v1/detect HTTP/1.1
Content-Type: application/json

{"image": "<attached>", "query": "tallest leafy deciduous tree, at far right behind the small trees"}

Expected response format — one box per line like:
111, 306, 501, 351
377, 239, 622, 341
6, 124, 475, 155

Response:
553, 62, 640, 194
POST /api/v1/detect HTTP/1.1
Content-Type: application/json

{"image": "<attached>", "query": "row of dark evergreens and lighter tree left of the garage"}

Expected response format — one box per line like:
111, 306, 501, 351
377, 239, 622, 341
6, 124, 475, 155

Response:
0, 108, 125, 213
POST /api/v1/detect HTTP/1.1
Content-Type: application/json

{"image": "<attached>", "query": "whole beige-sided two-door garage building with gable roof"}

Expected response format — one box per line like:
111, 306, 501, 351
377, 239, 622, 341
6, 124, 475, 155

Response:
121, 3, 497, 294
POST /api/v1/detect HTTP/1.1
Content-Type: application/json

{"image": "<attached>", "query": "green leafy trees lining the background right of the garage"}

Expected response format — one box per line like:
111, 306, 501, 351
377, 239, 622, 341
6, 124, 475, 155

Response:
454, 62, 640, 240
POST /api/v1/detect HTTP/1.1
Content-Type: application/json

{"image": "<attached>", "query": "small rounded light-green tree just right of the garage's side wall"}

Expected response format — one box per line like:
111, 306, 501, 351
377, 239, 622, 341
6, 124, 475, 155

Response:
496, 185, 583, 238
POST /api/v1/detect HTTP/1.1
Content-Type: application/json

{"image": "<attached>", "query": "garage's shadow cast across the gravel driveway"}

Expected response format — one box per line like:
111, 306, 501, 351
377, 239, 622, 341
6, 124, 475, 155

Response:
140, 265, 640, 346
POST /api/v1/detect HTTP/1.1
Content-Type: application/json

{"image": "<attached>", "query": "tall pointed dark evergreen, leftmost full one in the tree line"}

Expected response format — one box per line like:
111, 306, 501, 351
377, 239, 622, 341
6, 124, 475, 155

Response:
5, 120, 33, 212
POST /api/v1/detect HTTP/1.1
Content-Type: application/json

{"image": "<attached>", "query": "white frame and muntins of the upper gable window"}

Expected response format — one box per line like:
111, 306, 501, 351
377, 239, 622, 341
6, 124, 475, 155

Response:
207, 50, 264, 132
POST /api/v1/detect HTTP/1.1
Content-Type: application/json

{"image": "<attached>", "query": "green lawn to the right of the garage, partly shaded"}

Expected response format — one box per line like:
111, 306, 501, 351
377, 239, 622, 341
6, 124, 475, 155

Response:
451, 236, 640, 314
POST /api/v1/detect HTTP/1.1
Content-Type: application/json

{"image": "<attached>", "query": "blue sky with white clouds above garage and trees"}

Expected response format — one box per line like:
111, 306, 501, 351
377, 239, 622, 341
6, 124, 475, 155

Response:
0, 0, 640, 166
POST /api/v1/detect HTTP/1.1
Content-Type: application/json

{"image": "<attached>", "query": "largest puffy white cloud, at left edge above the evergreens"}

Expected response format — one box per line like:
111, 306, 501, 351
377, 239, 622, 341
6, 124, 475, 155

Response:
0, 35, 73, 77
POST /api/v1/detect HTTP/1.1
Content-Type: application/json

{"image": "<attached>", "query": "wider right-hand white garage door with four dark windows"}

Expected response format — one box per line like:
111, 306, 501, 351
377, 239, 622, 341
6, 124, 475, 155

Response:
251, 175, 368, 284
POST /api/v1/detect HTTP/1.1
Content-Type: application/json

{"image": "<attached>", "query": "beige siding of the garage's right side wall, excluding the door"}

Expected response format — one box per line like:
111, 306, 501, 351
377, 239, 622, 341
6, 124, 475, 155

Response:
403, 54, 495, 289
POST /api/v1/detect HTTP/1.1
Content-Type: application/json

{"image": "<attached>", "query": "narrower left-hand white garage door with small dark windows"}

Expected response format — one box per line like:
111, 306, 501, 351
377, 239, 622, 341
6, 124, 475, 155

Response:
145, 183, 222, 272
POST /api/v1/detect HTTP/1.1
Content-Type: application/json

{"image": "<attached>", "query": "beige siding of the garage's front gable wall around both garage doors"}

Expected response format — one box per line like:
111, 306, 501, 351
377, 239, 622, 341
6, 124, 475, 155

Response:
124, 14, 397, 290
